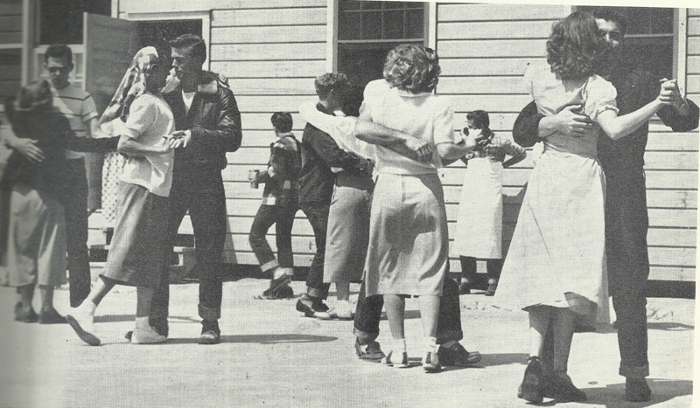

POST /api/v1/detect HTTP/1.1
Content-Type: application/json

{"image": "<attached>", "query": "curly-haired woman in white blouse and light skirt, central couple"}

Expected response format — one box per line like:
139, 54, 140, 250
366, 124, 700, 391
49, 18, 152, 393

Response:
360, 44, 476, 372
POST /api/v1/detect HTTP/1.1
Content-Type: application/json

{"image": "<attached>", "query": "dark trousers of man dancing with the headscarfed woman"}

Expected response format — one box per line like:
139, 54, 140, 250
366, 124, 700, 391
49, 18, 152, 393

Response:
151, 164, 228, 321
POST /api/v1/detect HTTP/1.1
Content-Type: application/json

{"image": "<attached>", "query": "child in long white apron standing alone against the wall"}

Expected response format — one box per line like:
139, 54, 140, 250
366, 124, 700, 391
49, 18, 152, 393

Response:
454, 110, 526, 296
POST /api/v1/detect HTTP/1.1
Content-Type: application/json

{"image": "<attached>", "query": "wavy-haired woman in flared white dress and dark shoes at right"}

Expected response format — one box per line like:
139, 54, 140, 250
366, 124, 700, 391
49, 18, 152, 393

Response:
496, 12, 665, 403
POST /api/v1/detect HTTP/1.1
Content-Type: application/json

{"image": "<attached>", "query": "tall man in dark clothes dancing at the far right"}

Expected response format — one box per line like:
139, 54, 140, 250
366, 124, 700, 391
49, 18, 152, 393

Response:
513, 9, 698, 401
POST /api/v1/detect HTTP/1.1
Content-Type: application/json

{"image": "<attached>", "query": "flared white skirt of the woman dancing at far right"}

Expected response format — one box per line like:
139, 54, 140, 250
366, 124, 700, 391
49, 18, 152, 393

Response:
495, 151, 609, 326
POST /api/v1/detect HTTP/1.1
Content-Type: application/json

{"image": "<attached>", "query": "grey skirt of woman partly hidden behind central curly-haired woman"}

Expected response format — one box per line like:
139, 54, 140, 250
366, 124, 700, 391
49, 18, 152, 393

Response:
323, 175, 372, 283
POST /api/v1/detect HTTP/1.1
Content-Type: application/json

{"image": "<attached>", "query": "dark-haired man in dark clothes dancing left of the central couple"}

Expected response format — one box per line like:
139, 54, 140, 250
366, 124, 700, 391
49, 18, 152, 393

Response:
296, 73, 372, 319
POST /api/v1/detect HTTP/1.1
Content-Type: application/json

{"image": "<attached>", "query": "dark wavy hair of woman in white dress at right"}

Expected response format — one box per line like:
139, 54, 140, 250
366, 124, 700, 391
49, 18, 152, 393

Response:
547, 11, 607, 79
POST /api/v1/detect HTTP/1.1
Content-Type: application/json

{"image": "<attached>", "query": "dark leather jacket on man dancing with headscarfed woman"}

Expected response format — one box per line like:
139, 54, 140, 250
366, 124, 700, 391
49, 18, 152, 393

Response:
163, 71, 242, 170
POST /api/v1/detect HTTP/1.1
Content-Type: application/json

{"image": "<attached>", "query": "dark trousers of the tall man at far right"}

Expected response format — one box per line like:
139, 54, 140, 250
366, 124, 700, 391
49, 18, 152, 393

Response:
605, 168, 649, 377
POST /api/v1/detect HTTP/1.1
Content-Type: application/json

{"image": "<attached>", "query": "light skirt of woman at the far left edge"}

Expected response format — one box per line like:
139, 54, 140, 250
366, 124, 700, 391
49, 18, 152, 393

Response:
7, 183, 66, 286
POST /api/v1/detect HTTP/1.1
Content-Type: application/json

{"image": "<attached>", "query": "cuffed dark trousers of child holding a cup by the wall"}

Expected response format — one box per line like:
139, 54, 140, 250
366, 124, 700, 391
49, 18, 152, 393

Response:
248, 204, 297, 272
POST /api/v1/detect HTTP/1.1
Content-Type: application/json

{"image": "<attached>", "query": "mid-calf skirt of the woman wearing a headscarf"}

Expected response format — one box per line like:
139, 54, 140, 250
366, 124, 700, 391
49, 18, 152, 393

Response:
100, 183, 169, 287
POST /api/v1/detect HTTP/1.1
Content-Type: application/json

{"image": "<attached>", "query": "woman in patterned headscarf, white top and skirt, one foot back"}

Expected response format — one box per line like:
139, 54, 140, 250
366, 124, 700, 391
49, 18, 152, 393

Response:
66, 47, 175, 346
